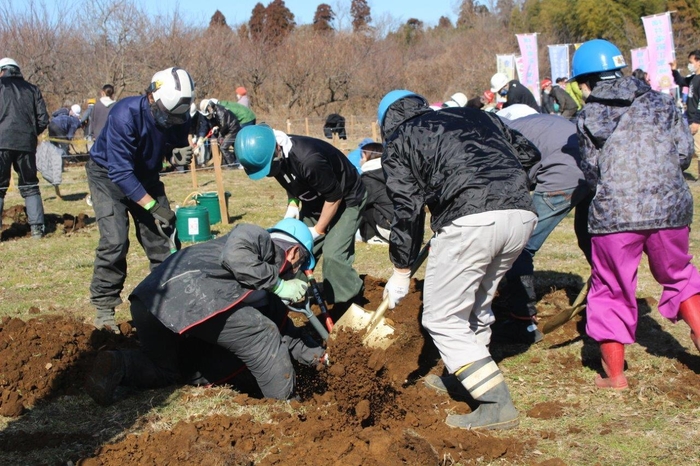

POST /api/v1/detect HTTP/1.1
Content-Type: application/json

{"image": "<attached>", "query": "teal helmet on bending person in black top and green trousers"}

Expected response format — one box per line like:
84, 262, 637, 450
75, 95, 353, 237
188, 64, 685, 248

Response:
234, 125, 277, 180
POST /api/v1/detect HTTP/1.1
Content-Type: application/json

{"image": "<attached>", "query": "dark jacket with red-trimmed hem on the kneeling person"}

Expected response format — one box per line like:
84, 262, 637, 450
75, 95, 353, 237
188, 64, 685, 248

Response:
129, 224, 285, 333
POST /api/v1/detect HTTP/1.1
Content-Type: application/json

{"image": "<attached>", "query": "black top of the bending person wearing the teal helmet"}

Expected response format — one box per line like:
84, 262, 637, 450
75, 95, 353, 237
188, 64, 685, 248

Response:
275, 135, 365, 207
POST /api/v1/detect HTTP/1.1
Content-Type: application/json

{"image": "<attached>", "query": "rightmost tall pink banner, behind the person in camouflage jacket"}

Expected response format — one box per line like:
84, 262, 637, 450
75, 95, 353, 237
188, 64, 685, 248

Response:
642, 13, 676, 92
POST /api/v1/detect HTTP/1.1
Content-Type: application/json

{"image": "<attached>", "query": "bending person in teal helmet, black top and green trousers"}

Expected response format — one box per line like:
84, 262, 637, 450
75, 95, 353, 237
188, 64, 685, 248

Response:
236, 125, 367, 304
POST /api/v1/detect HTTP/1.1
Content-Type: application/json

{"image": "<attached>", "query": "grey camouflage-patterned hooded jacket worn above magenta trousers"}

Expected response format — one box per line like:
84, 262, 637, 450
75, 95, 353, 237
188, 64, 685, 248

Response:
577, 77, 693, 234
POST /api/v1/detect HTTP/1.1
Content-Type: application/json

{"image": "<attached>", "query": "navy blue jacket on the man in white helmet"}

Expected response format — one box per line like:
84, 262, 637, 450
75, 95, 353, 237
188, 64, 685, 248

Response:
90, 95, 190, 201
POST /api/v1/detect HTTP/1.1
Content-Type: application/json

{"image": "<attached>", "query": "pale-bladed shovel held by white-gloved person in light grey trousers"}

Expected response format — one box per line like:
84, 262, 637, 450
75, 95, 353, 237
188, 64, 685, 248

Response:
333, 241, 430, 349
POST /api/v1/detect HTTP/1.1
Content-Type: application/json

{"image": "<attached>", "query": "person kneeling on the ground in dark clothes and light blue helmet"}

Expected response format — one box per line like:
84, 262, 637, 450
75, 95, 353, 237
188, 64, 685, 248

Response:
85, 219, 328, 406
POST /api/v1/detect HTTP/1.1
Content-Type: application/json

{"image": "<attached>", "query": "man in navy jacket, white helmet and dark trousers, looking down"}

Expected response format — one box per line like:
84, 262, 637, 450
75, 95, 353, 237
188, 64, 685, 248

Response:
85, 68, 194, 333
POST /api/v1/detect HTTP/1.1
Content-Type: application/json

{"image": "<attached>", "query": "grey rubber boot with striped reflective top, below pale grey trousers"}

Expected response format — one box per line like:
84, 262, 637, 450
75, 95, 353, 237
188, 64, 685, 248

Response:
446, 356, 519, 429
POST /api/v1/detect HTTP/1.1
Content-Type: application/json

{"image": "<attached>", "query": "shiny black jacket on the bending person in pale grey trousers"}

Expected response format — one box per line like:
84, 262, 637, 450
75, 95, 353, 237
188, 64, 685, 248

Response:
382, 97, 540, 268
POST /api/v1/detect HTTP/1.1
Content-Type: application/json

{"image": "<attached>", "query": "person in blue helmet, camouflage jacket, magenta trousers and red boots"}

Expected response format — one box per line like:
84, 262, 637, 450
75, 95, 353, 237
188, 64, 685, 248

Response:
572, 39, 700, 390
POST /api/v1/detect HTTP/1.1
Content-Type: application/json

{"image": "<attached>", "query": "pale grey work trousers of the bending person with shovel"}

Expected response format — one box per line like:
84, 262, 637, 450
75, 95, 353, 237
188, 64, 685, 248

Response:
423, 210, 537, 373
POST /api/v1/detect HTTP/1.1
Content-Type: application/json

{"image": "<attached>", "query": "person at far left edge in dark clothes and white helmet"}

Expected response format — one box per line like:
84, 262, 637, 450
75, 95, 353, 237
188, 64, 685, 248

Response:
0, 58, 49, 239
